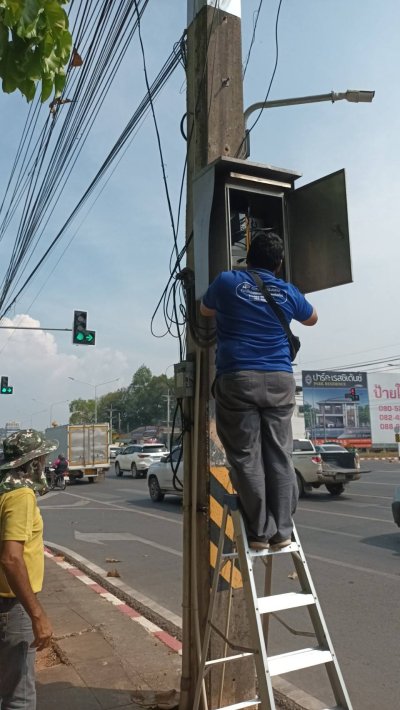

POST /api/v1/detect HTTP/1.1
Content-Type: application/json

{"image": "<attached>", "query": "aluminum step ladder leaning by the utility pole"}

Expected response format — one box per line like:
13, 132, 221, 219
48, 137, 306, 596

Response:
193, 494, 352, 710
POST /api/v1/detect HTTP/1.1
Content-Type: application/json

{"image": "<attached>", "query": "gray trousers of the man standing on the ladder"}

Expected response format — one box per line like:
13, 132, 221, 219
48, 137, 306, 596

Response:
215, 370, 298, 540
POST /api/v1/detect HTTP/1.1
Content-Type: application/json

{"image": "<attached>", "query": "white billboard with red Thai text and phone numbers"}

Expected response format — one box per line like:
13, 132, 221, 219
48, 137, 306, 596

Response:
367, 372, 400, 444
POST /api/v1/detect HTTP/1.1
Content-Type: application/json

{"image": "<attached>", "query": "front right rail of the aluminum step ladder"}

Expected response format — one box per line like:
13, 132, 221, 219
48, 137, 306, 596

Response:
292, 526, 352, 710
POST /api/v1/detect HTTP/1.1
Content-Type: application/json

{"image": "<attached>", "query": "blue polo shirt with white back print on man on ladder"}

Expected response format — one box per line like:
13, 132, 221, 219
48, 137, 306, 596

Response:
203, 269, 313, 375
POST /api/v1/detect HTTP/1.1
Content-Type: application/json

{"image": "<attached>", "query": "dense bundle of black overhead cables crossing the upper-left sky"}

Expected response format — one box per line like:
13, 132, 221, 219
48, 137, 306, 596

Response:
0, 0, 149, 315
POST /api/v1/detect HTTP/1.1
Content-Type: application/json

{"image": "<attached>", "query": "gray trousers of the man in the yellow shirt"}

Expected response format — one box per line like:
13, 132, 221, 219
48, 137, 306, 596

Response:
0, 598, 36, 710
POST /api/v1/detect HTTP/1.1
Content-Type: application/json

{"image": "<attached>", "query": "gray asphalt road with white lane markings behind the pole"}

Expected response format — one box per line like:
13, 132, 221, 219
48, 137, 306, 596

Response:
41, 462, 400, 710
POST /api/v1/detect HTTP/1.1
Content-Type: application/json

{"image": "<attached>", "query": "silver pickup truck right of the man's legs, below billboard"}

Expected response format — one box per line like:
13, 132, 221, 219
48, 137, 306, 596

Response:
292, 439, 360, 497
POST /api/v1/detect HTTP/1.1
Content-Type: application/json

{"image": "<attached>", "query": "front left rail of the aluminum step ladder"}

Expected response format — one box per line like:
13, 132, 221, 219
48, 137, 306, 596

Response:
231, 510, 276, 710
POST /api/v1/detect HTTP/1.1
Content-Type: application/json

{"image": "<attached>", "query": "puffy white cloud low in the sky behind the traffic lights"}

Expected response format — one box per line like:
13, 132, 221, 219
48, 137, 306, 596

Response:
0, 314, 132, 428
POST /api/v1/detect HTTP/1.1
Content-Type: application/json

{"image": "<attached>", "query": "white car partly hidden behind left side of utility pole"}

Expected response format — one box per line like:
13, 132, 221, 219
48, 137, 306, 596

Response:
147, 448, 183, 503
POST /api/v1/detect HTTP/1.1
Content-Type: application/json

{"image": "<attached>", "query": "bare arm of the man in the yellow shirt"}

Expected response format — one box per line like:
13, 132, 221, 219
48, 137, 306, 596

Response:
0, 540, 53, 651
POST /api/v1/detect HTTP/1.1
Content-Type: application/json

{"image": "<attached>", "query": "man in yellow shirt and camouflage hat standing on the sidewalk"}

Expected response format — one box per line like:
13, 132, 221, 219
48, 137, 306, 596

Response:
0, 429, 57, 710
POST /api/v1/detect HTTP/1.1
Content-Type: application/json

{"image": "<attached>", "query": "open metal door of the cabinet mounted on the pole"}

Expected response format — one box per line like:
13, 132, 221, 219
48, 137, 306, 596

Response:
286, 170, 352, 293
